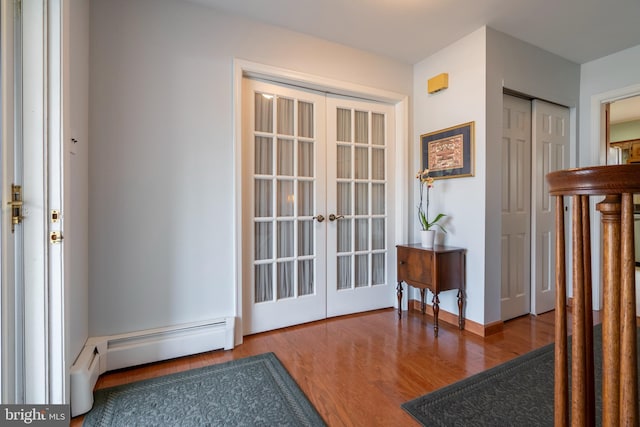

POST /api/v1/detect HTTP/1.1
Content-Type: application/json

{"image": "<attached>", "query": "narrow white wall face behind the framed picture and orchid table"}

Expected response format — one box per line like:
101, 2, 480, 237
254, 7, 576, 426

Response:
409, 28, 486, 324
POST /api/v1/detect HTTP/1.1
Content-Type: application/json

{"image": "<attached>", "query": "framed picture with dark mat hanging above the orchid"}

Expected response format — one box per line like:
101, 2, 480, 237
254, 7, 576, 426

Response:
420, 122, 475, 179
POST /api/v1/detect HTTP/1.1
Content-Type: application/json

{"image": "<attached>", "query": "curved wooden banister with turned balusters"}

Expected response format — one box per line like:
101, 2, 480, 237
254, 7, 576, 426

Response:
547, 164, 640, 426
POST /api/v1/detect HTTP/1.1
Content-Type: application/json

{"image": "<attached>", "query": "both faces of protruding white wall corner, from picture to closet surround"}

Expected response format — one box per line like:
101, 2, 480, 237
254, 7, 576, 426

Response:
411, 27, 580, 325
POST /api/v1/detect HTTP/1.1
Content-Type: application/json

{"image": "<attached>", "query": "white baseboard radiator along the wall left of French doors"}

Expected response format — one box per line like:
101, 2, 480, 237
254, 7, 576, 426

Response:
71, 317, 235, 417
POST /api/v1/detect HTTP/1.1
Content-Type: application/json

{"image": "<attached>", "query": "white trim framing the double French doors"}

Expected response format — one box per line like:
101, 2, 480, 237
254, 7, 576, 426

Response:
232, 58, 409, 345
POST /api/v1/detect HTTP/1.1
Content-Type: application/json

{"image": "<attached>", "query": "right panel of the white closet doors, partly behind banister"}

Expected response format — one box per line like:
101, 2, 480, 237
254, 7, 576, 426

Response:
531, 100, 569, 314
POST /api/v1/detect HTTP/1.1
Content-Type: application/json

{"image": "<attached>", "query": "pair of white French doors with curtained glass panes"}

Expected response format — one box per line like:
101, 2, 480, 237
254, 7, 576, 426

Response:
242, 78, 395, 334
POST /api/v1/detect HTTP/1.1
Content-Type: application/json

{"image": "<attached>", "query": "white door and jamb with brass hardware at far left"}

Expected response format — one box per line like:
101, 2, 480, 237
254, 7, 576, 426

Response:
1, 1, 68, 404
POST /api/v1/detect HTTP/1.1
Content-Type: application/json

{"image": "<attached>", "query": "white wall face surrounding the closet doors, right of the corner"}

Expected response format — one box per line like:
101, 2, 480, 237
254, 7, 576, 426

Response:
485, 28, 580, 323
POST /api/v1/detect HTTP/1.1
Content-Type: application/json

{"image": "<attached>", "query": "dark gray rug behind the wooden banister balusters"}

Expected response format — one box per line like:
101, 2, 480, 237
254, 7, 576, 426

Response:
402, 325, 640, 427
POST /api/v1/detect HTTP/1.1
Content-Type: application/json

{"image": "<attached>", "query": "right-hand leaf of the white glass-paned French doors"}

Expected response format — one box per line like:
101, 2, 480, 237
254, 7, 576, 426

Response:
327, 96, 395, 316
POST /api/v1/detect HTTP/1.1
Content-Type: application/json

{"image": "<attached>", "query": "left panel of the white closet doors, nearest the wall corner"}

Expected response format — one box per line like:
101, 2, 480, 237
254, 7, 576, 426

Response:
501, 95, 531, 320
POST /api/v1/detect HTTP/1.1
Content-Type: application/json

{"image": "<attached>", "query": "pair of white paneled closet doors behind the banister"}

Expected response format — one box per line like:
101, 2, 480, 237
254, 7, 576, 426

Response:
501, 95, 569, 320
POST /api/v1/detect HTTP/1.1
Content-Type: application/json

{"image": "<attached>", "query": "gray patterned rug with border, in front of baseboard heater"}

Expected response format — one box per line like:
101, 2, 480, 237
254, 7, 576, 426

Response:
83, 353, 325, 427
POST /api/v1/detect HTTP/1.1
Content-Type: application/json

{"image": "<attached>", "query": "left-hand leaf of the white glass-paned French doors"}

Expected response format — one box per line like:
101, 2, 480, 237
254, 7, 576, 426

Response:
242, 79, 326, 334
